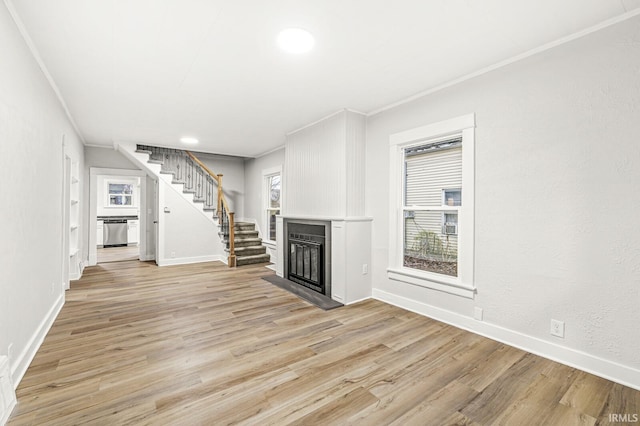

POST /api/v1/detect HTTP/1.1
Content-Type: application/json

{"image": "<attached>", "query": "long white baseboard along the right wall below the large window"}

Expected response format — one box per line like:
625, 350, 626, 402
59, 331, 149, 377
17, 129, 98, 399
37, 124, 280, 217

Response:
373, 289, 640, 390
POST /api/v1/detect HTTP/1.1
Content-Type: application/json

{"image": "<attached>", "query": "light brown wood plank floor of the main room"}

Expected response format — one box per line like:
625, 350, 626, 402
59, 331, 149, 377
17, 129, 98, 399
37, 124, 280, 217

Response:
9, 262, 640, 425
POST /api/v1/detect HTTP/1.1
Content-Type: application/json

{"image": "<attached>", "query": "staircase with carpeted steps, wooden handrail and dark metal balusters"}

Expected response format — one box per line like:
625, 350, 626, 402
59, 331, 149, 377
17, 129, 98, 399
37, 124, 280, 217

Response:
136, 145, 271, 266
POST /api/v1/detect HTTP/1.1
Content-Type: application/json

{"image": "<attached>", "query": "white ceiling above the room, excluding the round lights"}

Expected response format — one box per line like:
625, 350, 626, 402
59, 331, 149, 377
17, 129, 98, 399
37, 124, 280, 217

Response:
5, 0, 640, 156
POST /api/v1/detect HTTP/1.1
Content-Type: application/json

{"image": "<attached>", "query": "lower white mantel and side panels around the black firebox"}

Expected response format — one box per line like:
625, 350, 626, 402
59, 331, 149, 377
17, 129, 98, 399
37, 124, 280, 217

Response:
276, 216, 372, 305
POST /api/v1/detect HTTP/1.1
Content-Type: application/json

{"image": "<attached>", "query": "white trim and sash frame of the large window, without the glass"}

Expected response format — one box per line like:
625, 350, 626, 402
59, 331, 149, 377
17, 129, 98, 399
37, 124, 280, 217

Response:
387, 113, 476, 299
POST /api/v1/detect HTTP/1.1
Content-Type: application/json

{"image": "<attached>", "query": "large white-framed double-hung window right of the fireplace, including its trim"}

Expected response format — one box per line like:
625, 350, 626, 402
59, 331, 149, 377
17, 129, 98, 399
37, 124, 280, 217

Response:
388, 114, 475, 297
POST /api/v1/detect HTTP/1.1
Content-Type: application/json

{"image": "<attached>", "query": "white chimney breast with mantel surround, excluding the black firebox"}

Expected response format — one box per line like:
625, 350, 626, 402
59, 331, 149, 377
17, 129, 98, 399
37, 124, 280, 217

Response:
276, 109, 372, 305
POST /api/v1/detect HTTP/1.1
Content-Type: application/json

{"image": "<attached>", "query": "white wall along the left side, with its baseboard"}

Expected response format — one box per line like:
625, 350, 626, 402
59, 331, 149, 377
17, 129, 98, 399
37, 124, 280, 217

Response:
0, 3, 84, 386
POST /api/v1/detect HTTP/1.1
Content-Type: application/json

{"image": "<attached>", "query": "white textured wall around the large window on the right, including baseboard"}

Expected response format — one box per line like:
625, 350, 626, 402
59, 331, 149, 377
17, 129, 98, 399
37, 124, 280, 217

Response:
366, 17, 640, 388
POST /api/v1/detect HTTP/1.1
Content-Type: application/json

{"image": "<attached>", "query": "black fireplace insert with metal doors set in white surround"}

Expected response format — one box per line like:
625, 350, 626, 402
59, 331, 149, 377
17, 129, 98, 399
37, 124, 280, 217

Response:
284, 219, 331, 297
